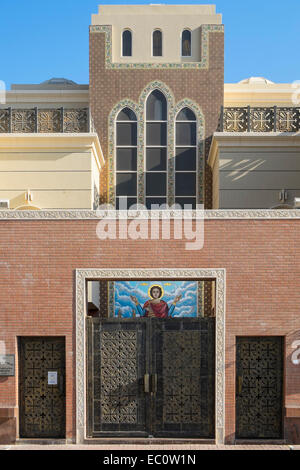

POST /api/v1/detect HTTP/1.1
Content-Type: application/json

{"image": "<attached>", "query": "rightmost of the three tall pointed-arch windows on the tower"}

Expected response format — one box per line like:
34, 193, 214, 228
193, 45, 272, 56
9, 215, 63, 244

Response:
175, 108, 197, 209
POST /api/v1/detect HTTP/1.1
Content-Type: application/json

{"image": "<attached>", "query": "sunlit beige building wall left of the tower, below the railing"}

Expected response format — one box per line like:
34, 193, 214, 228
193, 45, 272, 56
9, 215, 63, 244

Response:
0, 134, 104, 209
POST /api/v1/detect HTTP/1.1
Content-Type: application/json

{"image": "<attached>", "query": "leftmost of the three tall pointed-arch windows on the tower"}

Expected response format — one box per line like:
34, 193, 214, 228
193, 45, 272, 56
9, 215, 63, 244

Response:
116, 108, 137, 209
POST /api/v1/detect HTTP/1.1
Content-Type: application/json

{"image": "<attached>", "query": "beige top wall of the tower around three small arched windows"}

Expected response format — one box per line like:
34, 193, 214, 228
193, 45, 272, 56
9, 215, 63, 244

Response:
92, 5, 222, 63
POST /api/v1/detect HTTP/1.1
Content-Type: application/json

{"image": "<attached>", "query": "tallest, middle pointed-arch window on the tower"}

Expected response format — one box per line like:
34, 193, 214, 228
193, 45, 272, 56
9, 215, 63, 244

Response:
145, 90, 167, 209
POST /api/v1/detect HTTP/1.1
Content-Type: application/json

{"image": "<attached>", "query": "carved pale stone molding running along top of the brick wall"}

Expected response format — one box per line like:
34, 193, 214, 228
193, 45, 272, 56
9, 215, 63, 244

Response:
0, 209, 300, 220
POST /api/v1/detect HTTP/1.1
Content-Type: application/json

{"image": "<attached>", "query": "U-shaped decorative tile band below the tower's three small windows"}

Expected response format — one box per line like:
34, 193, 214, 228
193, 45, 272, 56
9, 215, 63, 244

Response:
90, 24, 224, 70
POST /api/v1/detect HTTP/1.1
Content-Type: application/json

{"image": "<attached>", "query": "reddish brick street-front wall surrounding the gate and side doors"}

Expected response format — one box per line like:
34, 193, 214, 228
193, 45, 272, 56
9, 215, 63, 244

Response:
0, 220, 300, 442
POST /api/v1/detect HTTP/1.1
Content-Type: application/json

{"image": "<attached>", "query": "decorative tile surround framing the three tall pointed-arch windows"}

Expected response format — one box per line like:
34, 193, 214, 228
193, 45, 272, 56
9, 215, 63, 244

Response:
107, 80, 205, 206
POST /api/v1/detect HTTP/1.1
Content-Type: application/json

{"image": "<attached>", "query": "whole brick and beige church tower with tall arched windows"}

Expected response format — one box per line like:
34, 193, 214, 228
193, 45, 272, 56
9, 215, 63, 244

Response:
90, 5, 224, 209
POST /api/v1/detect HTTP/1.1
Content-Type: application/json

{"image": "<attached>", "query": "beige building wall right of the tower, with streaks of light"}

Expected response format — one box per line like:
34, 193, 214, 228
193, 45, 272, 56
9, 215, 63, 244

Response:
209, 133, 300, 209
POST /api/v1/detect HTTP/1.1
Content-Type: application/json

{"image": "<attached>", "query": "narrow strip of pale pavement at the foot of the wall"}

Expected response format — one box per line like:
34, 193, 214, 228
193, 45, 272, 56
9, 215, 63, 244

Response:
0, 444, 300, 451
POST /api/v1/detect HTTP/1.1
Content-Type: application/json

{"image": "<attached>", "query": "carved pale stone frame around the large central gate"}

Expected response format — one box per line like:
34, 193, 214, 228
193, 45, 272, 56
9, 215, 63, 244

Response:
76, 268, 226, 444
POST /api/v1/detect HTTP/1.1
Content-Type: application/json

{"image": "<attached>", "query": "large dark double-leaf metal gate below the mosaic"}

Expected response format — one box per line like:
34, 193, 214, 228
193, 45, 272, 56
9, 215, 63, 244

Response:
87, 318, 215, 438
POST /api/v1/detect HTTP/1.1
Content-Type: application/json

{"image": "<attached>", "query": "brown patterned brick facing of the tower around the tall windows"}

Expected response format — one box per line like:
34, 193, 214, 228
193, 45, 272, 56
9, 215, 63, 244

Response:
90, 29, 224, 208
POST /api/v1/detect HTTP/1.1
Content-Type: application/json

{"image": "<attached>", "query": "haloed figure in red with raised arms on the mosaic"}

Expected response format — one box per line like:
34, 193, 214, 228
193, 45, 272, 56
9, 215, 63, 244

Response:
130, 285, 182, 318
